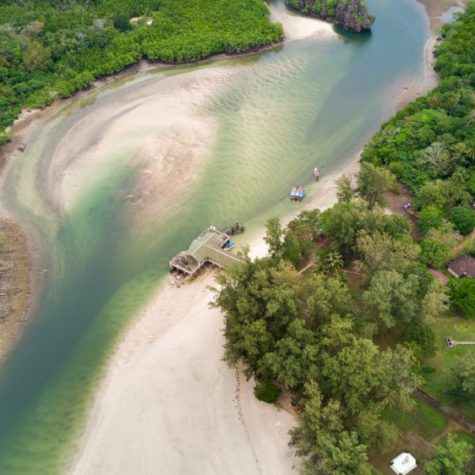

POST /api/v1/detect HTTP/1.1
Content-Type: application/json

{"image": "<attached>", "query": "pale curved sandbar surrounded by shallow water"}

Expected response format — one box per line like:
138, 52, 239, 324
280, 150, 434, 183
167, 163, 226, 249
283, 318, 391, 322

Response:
54, 67, 239, 219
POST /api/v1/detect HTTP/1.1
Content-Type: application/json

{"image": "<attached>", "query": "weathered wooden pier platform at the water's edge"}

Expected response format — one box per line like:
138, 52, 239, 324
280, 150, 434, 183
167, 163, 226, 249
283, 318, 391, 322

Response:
170, 223, 244, 276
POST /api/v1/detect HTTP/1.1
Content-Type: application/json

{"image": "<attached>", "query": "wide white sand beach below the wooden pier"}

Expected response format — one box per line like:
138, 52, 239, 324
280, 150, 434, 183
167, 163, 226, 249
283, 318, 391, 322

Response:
71, 272, 296, 475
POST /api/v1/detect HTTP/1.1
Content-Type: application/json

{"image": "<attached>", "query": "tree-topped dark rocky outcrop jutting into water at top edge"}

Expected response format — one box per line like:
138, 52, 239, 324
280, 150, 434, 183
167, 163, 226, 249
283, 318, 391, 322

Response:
286, 0, 374, 33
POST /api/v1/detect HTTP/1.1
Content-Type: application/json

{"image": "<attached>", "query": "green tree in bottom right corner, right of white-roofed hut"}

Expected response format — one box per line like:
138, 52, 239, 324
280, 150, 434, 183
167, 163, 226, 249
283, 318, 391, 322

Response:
424, 434, 472, 475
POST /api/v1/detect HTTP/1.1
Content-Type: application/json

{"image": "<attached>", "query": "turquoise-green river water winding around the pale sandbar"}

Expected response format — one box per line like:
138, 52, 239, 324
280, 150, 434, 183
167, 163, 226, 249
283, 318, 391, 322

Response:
0, 0, 428, 475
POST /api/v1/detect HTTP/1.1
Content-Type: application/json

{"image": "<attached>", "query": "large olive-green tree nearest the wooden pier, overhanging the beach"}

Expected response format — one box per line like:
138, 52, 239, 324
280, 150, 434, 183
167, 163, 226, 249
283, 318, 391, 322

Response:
213, 259, 299, 376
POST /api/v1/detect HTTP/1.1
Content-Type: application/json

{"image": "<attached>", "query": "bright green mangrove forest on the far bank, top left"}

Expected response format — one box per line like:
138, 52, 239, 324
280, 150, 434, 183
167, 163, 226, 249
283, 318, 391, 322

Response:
0, 0, 283, 139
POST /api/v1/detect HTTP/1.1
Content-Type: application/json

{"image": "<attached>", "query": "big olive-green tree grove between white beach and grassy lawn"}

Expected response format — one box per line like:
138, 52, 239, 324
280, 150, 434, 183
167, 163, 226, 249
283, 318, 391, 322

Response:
214, 195, 447, 474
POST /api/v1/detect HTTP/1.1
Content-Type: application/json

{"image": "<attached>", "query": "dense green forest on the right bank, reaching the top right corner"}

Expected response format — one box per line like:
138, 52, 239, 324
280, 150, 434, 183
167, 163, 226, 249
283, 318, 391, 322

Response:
362, 2, 475, 225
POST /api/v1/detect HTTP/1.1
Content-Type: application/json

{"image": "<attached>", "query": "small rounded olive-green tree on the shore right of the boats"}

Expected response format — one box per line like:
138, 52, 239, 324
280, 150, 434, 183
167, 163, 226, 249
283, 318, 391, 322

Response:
356, 162, 395, 209
